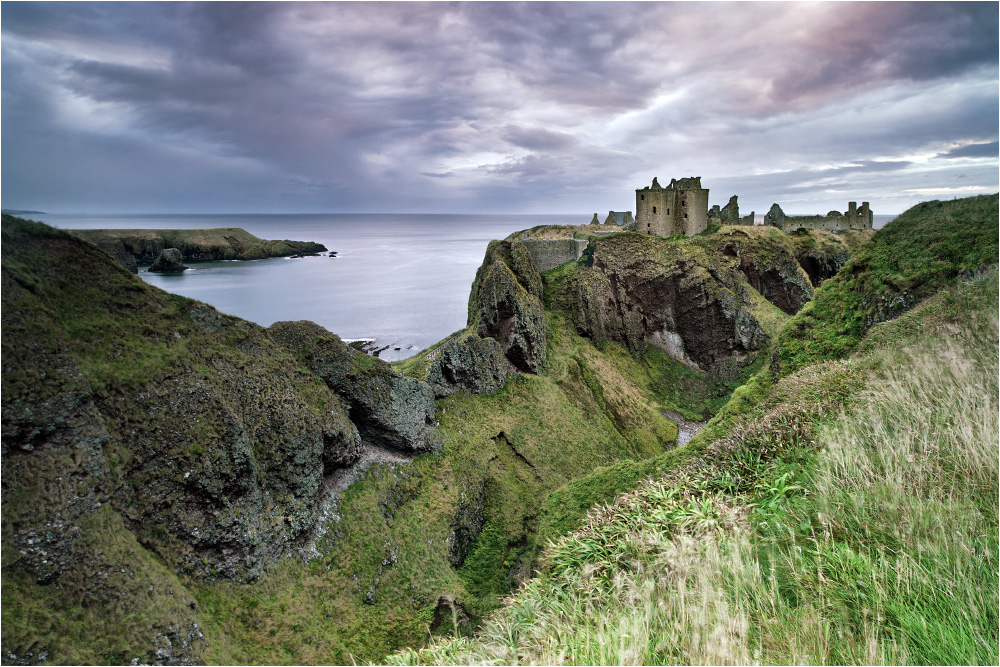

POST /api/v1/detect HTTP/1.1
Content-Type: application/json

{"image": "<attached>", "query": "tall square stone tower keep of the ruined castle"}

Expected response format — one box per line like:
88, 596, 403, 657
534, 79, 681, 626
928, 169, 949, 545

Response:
635, 176, 708, 236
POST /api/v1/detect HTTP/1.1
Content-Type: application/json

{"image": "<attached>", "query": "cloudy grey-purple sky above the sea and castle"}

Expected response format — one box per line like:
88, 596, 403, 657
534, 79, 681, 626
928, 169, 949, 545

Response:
0, 0, 1000, 214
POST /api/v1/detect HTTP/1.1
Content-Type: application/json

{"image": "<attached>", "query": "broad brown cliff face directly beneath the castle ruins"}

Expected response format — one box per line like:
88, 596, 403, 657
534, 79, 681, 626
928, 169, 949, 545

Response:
547, 227, 832, 376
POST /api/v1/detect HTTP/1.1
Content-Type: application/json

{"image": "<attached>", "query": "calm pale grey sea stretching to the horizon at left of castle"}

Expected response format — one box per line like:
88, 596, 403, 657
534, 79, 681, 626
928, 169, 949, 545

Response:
37, 214, 591, 361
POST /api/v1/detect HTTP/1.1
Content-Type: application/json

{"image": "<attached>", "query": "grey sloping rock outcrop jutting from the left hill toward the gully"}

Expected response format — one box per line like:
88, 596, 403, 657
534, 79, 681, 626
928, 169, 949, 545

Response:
268, 321, 440, 452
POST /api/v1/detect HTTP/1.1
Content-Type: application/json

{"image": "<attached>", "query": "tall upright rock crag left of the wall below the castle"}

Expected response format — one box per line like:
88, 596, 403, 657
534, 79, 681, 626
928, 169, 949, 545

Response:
469, 241, 546, 374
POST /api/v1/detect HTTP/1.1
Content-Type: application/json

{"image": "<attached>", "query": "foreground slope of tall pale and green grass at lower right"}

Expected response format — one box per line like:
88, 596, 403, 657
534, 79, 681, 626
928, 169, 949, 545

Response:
390, 198, 1000, 664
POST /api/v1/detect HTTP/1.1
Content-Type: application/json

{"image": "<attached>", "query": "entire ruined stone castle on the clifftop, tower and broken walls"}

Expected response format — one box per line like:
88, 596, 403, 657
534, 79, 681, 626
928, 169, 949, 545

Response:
591, 176, 874, 236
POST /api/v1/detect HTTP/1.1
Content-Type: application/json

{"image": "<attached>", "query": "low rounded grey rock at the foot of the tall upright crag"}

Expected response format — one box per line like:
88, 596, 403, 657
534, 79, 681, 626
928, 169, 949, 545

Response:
427, 334, 507, 398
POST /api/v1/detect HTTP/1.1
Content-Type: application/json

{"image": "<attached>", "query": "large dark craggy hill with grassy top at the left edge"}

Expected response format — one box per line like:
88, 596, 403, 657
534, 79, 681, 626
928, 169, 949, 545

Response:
2, 218, 361, 592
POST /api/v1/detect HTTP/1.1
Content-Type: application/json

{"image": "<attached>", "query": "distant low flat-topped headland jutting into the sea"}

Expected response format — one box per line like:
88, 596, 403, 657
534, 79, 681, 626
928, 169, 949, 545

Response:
71, 227, 326, 273
